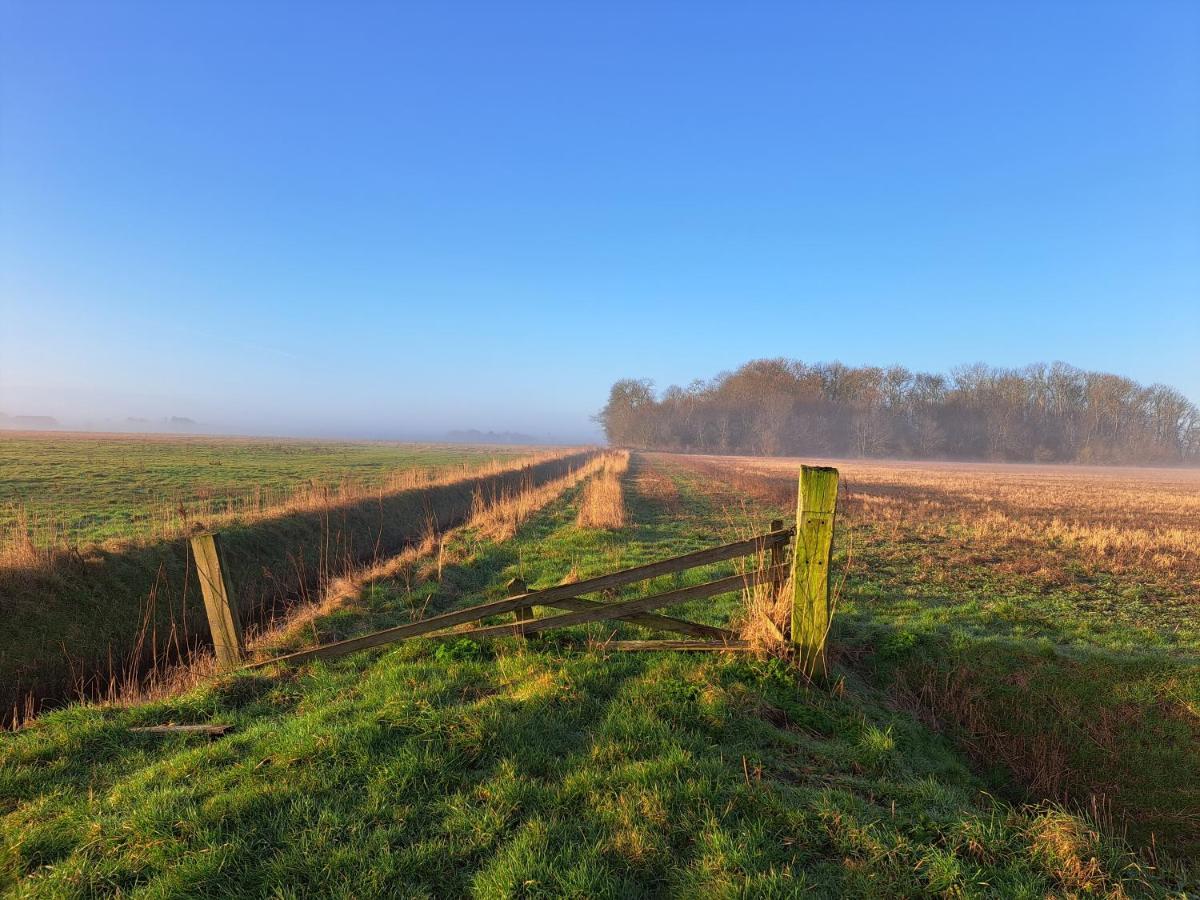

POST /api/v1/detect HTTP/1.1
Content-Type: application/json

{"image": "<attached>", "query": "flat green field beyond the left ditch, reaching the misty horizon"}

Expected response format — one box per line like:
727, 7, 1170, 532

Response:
0, 431, 529, 545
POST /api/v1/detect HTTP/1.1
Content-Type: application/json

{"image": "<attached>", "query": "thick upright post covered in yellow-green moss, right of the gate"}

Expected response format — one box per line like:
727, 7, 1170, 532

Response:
792, 466, 838, 677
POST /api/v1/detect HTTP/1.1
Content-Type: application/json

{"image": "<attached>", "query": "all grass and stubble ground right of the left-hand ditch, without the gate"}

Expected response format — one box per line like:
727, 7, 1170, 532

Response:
0, 454, 1200, 898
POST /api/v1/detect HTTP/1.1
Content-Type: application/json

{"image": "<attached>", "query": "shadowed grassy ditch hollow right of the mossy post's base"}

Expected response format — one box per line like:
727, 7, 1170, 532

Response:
832, 613, 1200, 859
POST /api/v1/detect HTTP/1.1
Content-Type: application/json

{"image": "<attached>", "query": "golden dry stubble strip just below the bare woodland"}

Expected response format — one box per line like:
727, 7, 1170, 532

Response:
683, 456, 1200, 595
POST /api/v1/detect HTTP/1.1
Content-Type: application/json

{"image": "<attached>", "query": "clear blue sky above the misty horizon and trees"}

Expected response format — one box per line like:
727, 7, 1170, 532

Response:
0, 0, 1200, 437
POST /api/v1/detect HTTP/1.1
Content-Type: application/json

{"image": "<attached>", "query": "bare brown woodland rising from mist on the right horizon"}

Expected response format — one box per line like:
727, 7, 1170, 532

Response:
599, 359, 1200, 463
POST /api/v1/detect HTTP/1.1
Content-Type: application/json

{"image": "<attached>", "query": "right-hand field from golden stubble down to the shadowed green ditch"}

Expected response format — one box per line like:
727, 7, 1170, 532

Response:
677, 458, 1200, 877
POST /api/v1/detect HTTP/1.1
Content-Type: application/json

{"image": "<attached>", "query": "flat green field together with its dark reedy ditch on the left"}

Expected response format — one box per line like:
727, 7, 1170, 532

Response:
0, 436, 582, 724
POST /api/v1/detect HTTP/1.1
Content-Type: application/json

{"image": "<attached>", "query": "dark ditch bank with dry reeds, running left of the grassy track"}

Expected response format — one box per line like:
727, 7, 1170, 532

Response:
0, 451, 586, 722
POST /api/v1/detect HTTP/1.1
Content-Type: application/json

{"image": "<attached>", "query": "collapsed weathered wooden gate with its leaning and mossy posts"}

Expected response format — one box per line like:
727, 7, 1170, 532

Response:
193, 466, 838, 674
